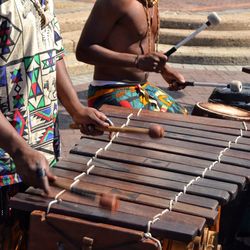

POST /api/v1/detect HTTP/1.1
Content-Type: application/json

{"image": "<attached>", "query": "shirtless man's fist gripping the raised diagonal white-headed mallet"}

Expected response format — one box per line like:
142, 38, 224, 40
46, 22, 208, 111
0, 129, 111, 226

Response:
136, 52, 168, 73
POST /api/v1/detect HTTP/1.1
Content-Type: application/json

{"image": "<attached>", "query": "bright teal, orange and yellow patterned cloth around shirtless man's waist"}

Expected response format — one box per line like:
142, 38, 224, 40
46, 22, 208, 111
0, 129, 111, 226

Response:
88, 82, 187, 114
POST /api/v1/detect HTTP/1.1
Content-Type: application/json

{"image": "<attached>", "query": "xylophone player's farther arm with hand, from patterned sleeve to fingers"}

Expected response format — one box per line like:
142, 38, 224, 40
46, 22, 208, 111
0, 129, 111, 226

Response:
56, 59, 109, 135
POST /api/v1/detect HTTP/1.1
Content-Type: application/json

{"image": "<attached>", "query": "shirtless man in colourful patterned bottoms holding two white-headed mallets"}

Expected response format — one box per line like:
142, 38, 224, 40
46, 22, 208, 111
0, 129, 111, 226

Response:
76, 0, 187, 114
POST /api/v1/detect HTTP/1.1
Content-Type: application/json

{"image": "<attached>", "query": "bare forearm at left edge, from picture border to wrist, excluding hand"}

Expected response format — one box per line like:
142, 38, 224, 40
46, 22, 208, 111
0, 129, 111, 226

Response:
0, 112, 28, 156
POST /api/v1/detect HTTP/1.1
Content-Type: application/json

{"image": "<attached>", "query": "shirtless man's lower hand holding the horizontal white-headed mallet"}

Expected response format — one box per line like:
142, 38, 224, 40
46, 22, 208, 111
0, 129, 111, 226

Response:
161, 65, 186, 91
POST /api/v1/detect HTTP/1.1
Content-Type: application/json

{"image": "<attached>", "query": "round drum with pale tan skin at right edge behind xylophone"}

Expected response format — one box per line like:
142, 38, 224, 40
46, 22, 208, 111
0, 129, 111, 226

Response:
192, 102, 250, 121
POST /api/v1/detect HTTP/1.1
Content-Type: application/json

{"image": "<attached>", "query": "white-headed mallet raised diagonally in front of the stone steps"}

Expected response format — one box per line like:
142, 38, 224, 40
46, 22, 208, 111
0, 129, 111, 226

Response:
165, 12, 221, 57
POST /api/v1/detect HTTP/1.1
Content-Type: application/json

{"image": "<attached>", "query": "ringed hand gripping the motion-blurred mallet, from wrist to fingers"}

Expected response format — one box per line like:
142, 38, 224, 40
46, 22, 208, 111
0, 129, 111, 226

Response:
12, 146, 55, 195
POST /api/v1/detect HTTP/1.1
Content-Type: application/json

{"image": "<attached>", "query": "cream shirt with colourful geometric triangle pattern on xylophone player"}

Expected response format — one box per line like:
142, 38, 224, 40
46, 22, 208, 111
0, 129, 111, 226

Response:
0, 0, 63, 187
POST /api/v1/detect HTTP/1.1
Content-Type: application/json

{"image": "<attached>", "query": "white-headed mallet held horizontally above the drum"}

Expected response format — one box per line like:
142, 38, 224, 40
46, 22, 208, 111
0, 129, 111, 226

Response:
185, 80, 242, 92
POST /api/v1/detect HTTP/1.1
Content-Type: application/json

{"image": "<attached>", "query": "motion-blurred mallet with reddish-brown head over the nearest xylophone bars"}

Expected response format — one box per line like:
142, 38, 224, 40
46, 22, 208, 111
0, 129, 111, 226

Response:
50, 177, 119, 212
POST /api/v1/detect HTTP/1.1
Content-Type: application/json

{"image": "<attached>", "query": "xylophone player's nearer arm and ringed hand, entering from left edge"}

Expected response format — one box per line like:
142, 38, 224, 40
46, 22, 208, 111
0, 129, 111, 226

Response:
0, 112, 54, 194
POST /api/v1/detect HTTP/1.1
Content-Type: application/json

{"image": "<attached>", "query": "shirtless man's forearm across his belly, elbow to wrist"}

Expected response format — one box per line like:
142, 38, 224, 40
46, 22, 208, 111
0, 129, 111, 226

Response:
76, 44, 137, 67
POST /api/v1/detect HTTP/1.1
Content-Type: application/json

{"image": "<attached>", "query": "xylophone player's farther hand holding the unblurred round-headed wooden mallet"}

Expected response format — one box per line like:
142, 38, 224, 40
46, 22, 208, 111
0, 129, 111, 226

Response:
72, 106, 109, 135
